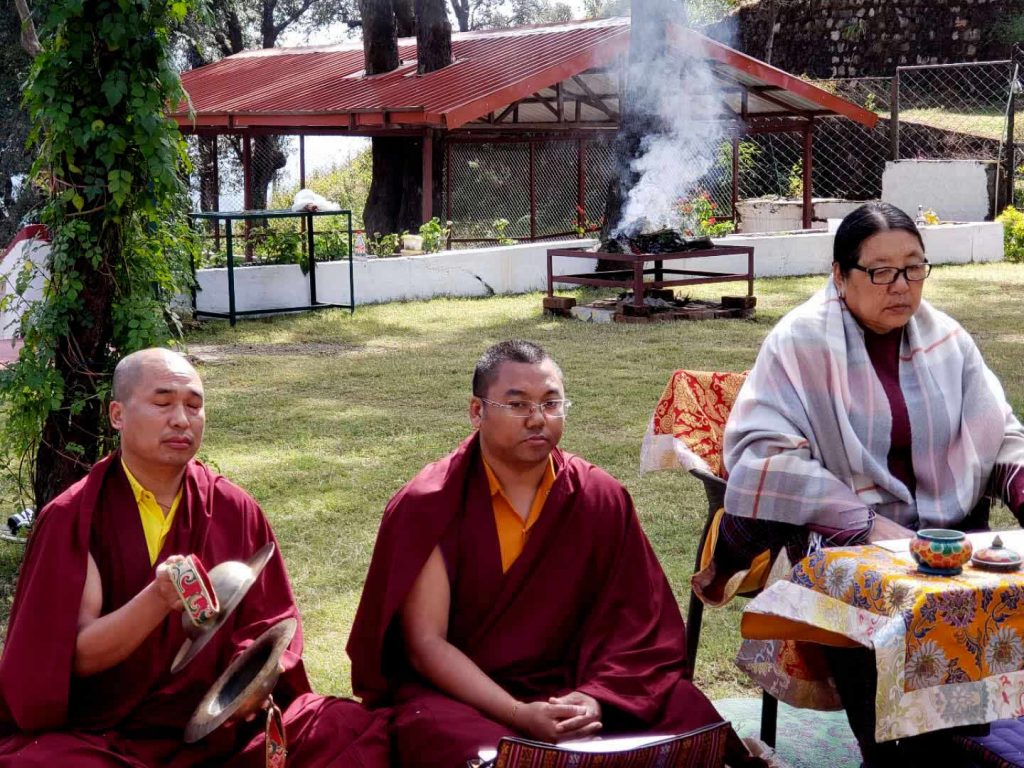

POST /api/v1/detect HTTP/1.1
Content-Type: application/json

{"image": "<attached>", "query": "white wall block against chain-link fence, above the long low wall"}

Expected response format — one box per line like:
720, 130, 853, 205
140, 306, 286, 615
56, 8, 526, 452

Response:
882, 160, 991, 221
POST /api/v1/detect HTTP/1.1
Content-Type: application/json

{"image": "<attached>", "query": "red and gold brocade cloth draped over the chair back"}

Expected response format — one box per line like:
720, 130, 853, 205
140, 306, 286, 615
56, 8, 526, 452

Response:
640, 371, 746, 477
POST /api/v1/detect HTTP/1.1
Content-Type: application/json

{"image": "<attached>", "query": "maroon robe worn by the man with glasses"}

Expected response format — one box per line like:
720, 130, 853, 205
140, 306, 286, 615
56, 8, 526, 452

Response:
348, 434, 749, 768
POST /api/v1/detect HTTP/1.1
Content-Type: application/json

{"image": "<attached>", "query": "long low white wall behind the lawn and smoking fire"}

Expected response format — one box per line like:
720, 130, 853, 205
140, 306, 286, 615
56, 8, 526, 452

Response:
190, 222, 1002, 312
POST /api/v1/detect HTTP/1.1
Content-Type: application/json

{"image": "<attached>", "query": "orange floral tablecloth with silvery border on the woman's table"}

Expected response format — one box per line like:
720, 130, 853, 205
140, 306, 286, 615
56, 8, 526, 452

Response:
736, 545, 1024, 741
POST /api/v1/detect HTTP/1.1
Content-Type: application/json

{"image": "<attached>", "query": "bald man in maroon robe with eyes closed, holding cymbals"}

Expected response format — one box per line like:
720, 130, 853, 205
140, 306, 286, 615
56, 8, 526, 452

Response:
0, 349, 387, 768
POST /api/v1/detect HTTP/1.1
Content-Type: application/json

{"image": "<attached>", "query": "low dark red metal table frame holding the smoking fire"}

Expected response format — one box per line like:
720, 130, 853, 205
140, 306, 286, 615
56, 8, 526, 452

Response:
548, 246, 754, 311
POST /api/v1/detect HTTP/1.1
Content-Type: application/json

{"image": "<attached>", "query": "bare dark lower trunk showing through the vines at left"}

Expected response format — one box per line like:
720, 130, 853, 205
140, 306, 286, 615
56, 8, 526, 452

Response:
33, 226, 124, 510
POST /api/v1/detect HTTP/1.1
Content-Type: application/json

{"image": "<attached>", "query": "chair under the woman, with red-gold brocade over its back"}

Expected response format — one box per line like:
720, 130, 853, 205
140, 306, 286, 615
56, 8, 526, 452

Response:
641, 371, 778, 746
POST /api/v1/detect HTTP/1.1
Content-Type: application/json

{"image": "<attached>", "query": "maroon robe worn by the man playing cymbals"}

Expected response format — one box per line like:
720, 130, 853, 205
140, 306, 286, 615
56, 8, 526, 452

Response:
0, 454, 387, 768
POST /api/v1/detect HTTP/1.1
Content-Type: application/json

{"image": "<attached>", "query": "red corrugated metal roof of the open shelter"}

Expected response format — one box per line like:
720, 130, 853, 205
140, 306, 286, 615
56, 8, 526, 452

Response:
172, 18, 878, 135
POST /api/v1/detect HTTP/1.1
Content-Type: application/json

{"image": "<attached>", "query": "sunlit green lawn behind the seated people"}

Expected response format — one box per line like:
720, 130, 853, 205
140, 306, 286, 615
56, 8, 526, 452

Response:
0, 264, 1024, 697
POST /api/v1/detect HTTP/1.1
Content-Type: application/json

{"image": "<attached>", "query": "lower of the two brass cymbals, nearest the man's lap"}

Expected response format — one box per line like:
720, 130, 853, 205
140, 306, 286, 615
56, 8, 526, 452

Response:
184, 618, 299, 744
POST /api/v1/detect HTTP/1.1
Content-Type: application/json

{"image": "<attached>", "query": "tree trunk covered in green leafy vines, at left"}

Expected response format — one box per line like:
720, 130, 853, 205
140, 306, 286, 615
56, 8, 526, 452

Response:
0, 0, 195, 506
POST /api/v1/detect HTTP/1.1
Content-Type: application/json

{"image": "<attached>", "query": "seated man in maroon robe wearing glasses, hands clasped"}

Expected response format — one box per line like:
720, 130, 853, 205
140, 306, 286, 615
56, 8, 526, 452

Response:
348, 341, 761, 768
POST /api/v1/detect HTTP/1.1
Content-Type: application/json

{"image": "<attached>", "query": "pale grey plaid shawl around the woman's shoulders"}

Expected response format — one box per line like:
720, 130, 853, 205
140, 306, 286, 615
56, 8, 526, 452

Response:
725, 280, 1024, 531
